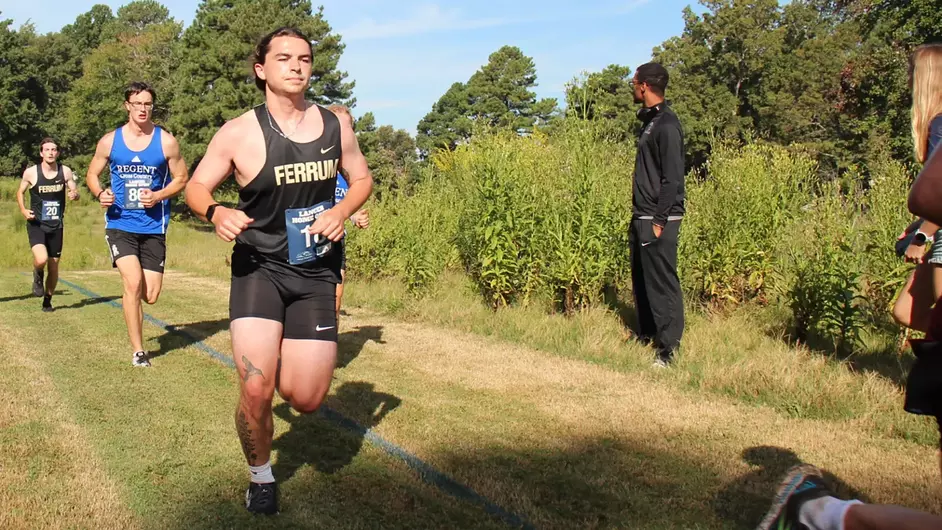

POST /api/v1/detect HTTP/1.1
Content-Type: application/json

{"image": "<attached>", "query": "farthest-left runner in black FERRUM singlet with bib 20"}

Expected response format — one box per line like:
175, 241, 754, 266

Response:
16, 138, 78, 312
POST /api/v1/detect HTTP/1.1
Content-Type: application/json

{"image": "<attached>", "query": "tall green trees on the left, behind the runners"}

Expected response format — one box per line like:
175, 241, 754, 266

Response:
0, 0, 416, 192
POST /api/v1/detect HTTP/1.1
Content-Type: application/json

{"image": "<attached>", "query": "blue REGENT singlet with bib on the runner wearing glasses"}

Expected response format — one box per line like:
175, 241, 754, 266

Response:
105, 126, 170, 234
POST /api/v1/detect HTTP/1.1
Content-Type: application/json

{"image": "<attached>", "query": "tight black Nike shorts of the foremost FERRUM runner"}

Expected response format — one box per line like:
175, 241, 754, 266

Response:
229, 248, 337, 342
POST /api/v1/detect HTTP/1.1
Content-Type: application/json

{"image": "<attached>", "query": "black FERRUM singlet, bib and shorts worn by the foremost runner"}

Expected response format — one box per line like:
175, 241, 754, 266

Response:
229, 105, 342, 341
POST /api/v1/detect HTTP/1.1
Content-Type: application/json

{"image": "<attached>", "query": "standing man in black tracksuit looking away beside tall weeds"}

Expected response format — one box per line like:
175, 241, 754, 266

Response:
629, 63, 684, 367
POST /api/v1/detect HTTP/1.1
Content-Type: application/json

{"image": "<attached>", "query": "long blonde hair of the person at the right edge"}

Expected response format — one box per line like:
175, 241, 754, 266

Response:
912, 44, 942, 163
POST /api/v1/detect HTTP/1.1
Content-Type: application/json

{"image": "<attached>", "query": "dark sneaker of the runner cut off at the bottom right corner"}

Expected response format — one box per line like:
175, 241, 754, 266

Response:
756, 464, 834, 530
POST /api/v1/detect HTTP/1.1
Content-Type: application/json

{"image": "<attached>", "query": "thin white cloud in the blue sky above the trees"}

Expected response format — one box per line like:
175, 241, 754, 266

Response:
339, 4, 511, 41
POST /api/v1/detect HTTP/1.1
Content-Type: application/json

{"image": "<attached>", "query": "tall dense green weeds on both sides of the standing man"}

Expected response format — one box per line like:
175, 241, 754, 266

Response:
348, 127, 911, 350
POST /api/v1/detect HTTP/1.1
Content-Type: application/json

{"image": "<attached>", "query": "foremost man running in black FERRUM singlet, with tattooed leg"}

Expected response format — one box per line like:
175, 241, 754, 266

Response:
186, 28, 373, 514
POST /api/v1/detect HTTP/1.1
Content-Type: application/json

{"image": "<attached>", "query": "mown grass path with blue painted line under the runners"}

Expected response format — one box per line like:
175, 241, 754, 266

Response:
0, 271, 942, 528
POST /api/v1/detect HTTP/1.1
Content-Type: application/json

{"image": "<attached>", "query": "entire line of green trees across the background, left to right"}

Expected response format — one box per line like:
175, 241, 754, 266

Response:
0, 0, 942, 185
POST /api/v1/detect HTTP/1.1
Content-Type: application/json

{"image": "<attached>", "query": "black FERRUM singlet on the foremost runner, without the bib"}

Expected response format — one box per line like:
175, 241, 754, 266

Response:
236, 105, 341, 269
